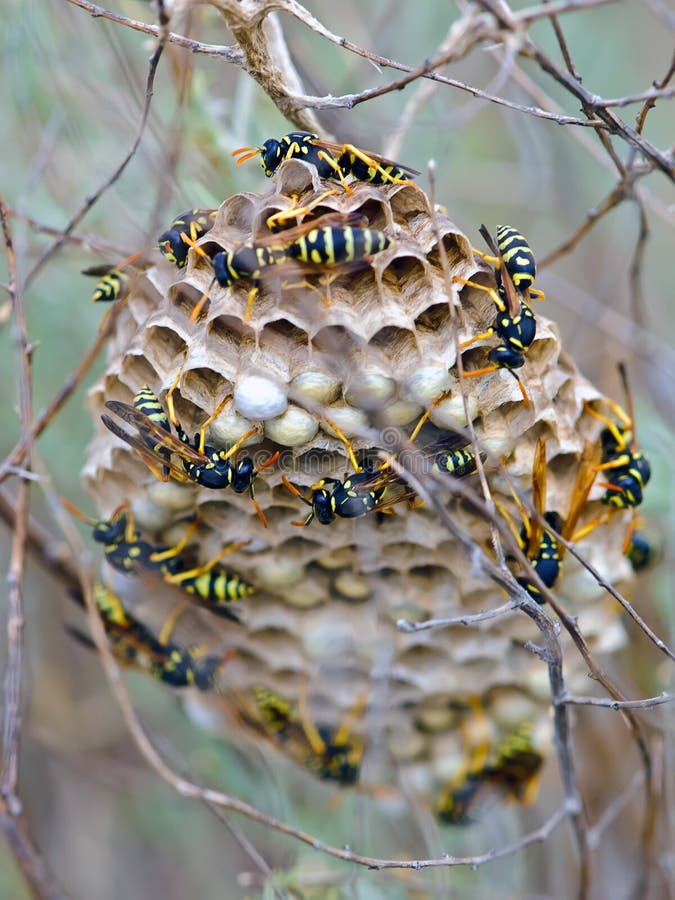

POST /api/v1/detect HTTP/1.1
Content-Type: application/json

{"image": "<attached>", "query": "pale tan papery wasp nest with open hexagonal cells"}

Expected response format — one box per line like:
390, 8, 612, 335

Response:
85, 160, 629, 808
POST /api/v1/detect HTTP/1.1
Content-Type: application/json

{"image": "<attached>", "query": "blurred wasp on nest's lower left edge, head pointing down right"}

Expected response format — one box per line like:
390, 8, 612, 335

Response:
68, 582, 229, 691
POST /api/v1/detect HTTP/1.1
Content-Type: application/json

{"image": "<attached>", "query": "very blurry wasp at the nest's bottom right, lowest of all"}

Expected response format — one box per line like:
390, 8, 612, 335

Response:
437, 723, 544, 825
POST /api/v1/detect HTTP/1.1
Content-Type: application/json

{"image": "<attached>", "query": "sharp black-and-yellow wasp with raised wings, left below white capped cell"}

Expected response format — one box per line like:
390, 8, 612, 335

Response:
101, 370, 279, 527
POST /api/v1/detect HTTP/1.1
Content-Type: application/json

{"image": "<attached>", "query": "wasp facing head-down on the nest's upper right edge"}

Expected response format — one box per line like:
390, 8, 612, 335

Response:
453, 225, 537, 406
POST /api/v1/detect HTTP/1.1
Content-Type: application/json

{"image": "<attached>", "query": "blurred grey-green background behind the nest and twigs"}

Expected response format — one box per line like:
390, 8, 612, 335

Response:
0, 0, 675, 900
